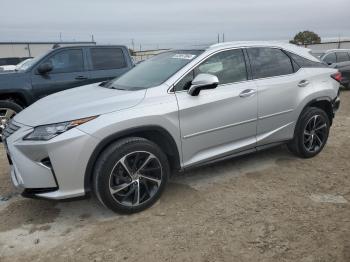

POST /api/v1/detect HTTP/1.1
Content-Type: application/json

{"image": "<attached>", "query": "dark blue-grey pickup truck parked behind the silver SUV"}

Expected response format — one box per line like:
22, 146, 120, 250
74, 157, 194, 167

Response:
0, 45, 134, 138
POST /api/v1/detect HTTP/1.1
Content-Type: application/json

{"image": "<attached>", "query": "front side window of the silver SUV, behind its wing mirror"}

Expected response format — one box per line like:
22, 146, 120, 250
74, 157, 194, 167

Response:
175, 49, 247, 91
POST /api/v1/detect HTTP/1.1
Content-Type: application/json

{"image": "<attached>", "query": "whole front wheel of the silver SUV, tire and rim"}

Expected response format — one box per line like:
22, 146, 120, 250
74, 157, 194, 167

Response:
93, 137, 170, 213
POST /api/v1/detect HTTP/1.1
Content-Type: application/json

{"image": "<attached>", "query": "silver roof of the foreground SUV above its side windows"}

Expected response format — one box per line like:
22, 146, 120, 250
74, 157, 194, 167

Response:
208, 41, 319, 62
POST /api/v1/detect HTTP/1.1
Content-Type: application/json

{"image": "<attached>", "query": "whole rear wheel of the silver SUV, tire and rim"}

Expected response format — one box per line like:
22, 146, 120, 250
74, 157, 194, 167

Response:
288, 107, 330, 158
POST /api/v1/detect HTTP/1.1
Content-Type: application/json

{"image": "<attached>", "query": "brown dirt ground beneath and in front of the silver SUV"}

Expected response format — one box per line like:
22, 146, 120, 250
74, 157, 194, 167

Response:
0, 91, 350, 262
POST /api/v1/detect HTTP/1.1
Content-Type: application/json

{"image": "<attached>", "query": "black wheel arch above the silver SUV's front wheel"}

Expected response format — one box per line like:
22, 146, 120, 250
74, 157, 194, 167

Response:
84, 125, 181, 195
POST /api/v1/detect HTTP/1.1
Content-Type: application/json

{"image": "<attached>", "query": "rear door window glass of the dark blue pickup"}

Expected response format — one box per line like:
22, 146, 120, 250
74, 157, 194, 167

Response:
91, 48, 126, 70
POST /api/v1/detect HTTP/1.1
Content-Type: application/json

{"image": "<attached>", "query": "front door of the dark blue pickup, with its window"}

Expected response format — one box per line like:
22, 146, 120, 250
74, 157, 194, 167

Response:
32, 48, 89, 99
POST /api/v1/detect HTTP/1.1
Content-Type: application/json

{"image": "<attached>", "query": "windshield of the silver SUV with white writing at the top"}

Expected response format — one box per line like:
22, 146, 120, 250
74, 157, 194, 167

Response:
106, 50, 203, 90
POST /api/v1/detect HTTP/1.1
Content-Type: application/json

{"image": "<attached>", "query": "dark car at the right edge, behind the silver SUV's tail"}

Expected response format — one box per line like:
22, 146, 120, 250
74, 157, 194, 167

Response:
321, 49, 350, 89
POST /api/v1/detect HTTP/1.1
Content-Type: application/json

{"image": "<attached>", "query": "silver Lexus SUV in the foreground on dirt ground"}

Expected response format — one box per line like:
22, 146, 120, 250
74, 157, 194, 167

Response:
4, 42, 341, 213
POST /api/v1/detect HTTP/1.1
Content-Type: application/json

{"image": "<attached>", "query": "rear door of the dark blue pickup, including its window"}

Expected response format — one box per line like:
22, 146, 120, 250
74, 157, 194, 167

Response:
88, 47, 131, 82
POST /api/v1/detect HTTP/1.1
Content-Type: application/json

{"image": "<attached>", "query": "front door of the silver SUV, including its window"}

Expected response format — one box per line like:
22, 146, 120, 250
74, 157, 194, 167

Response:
175, 49, 257, 167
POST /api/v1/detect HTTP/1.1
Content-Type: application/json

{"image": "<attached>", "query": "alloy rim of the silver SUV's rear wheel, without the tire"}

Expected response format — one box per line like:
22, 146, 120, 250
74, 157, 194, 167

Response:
303, 115, 328, 152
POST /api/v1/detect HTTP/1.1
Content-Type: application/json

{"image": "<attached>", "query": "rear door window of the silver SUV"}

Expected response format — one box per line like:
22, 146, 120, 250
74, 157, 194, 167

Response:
247, 47, 294, 78
